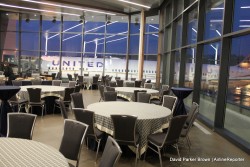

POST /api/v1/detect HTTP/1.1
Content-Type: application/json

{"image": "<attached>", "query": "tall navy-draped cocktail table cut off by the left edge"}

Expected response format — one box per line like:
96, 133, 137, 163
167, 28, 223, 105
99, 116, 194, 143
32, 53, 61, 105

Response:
0, 86, 20, 136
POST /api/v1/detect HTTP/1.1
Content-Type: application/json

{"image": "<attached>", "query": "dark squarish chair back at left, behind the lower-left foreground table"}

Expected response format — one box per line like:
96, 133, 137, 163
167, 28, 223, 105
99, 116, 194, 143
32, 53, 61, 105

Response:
7, 113, 36, 140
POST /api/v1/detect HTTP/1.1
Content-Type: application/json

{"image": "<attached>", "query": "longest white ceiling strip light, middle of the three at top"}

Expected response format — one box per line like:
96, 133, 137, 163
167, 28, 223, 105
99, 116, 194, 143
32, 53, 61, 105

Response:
22, 0, 116, 15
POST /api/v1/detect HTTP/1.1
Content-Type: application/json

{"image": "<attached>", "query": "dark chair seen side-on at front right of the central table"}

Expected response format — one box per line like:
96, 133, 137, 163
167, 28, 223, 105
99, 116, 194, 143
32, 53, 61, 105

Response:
144, 115, 187, 167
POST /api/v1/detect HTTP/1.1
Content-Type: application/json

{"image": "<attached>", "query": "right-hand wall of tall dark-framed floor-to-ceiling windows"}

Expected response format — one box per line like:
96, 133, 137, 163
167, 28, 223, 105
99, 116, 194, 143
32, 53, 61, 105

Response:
162, 0, 250, 152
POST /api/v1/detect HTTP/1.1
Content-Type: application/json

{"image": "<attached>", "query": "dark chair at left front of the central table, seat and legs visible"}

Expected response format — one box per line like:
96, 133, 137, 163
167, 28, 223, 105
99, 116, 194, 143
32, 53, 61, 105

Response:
73, 108, 104, 160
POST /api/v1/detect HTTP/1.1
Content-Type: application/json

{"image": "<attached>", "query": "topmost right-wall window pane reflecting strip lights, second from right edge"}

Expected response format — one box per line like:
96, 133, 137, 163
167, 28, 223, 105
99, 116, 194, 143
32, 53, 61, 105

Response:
204, 0, 224, 39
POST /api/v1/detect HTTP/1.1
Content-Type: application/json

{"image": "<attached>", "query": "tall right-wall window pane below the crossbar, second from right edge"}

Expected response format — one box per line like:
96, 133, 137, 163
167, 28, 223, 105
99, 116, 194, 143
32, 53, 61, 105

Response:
200, 42, 221, 122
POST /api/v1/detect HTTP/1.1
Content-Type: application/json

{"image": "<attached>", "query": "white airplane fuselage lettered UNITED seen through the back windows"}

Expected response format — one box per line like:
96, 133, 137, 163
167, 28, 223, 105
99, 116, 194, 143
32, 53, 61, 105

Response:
41, 56, 157, 81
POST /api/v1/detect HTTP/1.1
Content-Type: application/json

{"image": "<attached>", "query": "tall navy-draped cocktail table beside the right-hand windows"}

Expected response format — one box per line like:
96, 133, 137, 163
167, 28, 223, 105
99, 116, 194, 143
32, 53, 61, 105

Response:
171, 87, 193, 116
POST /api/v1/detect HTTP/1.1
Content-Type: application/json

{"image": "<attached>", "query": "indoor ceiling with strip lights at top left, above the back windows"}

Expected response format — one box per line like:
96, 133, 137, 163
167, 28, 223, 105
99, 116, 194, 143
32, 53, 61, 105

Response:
0, 0, 164, 15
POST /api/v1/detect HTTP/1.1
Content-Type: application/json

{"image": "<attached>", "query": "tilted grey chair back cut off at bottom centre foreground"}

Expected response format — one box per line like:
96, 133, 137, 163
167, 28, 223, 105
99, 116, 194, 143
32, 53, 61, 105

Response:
99, 136, 122, 167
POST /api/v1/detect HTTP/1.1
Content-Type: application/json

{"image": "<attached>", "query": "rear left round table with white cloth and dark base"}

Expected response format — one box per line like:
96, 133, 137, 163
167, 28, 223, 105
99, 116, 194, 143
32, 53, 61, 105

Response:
18, 85, 65, 113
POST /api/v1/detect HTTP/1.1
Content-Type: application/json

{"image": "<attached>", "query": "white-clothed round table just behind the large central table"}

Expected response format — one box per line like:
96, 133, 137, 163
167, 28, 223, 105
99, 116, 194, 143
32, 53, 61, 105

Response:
115, 87, 159, 101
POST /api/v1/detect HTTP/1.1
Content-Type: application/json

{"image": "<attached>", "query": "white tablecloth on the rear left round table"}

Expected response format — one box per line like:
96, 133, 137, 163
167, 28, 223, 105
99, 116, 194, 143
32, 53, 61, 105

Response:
18, 85, 65, 99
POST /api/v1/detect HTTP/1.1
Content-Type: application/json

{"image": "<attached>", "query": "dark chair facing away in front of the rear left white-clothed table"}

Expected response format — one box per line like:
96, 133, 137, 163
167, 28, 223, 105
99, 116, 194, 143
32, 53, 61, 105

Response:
27, 88, 46, 116
